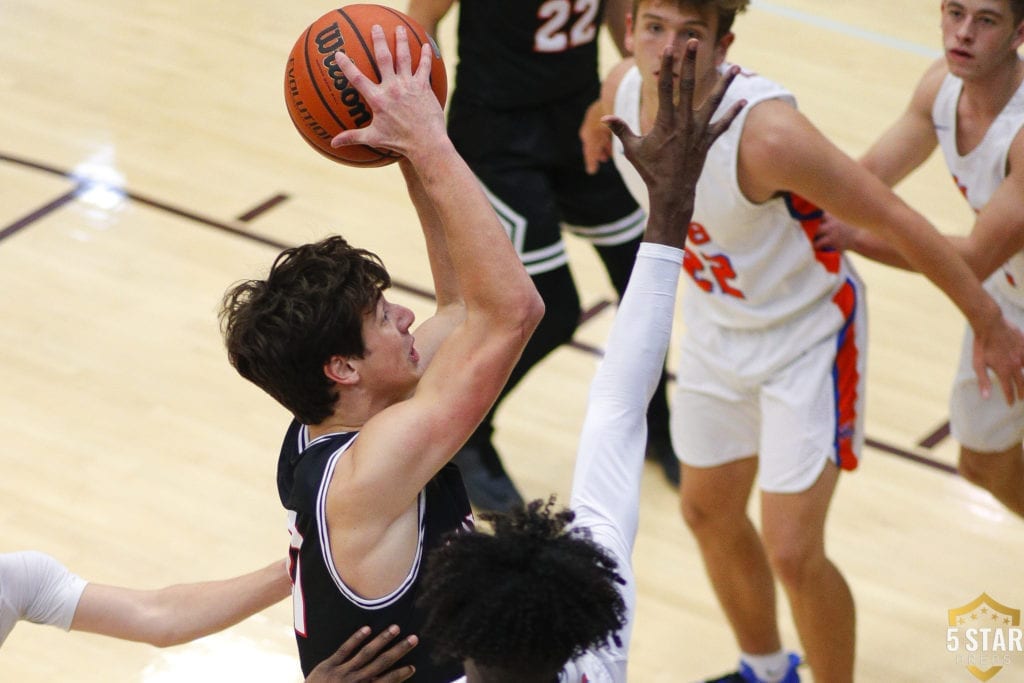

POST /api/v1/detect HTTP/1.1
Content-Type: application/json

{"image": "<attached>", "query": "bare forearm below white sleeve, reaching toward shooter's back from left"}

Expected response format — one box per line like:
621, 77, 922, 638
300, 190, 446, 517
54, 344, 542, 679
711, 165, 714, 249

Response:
71, 561, 291, 647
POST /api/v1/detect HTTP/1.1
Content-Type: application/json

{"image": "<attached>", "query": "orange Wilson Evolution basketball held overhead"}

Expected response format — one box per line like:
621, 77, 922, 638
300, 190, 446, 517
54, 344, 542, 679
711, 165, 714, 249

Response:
285, 4, 447, 167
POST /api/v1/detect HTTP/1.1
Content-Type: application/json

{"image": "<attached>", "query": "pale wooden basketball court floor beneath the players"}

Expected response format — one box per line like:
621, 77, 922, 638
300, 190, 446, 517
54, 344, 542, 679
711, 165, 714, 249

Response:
0, 0, 1024, 683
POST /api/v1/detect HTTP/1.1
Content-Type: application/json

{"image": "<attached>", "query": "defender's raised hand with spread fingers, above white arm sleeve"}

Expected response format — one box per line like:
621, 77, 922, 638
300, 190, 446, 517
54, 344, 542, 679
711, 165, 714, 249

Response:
602, 40, 746, 240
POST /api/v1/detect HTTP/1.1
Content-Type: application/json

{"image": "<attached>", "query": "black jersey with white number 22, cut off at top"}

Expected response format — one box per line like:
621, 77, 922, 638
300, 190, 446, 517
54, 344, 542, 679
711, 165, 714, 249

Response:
453, 0, 604, 109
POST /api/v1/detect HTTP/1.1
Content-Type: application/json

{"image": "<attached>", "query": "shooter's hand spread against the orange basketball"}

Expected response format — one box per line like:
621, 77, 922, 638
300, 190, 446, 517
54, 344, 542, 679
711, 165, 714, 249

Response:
331, 25, 447, 157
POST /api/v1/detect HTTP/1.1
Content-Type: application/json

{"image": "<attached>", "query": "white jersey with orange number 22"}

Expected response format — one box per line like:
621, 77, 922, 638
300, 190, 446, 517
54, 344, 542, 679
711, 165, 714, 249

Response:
612, 65, 847, 330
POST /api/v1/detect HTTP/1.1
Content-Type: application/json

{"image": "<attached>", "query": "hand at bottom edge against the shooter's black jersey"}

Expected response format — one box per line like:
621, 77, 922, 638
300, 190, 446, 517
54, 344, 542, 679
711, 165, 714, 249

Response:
305, 626, 419, 683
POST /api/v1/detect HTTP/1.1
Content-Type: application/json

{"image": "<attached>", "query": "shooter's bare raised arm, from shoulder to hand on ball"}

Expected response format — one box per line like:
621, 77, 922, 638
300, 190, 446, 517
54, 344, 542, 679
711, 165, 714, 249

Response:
328, 28, 544, 511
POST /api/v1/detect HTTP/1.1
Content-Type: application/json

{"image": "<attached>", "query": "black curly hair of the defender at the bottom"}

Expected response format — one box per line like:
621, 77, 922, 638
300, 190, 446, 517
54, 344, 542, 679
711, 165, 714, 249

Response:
418, 497, 626, 681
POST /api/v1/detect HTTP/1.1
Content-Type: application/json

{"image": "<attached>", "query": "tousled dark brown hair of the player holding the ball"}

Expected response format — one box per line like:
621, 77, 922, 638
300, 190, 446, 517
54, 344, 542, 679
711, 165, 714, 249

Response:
218, 236, 391, 425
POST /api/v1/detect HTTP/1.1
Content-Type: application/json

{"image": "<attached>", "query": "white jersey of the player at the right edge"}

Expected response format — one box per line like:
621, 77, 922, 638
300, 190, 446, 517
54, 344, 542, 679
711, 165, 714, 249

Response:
932, 74, 1024, 306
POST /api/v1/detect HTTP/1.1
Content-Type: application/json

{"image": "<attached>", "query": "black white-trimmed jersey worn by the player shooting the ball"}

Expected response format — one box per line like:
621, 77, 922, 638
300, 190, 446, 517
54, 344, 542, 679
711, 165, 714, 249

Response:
278, 422, 472, 683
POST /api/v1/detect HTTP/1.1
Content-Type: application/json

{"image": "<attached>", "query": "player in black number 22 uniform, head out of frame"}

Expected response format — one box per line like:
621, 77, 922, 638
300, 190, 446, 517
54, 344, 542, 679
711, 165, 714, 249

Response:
407, 0, 679, 510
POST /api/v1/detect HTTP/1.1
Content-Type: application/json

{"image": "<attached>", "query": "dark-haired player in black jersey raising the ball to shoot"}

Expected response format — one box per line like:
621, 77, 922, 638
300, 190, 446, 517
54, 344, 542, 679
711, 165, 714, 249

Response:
221, 27, 544, 681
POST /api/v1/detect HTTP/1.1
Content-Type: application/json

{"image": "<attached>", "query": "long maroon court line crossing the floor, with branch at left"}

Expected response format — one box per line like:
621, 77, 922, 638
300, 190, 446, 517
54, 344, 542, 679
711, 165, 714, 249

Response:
0, 153, 956, 474
